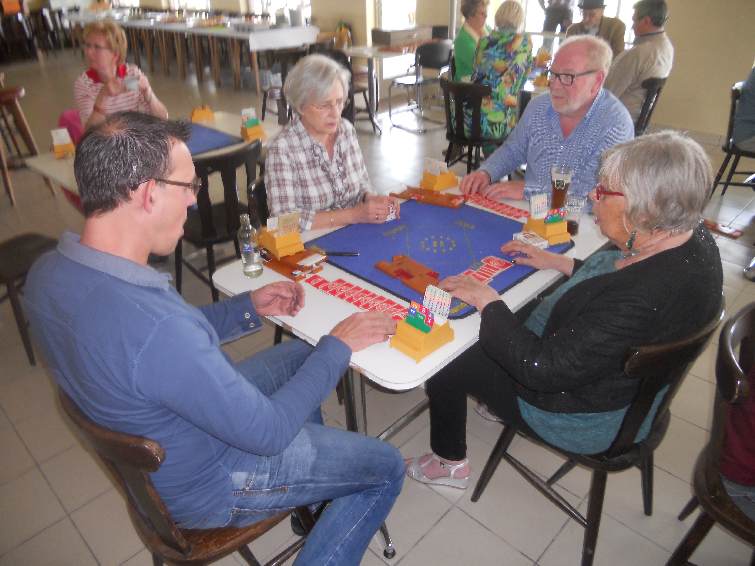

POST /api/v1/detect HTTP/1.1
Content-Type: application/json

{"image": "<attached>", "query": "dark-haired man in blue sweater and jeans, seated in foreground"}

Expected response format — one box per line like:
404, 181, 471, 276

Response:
26, 112, 404, 565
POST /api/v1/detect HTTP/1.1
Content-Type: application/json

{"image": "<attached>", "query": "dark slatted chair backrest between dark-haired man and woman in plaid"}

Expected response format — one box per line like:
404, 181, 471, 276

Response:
194, 140, 262, 240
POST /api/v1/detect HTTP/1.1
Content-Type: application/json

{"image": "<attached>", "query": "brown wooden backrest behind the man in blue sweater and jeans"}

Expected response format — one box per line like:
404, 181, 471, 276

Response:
58, 388, 190, 554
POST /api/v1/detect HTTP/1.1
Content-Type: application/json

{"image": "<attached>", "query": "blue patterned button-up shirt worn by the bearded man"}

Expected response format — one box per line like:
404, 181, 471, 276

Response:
480, 89, 634, 198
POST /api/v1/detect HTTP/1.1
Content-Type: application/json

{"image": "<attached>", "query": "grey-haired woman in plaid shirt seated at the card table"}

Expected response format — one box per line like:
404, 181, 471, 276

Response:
265, 55, 399, 230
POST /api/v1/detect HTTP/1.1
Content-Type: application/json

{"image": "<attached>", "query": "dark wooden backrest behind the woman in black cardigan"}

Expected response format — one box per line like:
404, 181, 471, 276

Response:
604, 299, 724, 458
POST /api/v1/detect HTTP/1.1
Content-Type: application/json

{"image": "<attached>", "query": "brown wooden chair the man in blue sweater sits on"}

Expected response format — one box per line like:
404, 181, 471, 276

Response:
58, 389, 314, 566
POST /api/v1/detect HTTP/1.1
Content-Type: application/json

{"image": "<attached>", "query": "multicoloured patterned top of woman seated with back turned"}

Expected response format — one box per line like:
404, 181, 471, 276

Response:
469, 29, 533, 145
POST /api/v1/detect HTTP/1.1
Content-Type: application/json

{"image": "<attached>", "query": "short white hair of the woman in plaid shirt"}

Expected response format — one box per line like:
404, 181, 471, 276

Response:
283, 55, 351, 114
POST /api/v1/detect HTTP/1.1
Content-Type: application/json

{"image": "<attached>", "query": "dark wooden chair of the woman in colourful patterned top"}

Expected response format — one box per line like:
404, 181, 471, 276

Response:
440, 78, 503, 173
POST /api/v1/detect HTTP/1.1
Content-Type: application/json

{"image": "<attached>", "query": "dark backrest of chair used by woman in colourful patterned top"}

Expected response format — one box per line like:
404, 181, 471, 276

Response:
440, 78, 491, 145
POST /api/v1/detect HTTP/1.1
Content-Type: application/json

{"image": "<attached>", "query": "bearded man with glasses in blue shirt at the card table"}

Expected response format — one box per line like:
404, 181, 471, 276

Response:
461, 36, 634, 200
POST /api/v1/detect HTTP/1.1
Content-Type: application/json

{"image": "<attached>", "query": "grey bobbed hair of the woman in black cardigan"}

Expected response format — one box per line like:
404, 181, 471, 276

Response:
599, 130, 713, 232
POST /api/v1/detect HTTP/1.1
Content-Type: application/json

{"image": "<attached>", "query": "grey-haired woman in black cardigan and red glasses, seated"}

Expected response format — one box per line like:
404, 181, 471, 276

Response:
407, 132, 722, 488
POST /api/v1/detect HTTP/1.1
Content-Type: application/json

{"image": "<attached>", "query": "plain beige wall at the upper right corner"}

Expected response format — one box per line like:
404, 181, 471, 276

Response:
636, 0, 755, 136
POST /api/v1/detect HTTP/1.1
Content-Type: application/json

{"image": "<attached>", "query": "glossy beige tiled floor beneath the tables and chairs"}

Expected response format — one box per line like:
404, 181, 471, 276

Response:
0, 53, 755, 566
